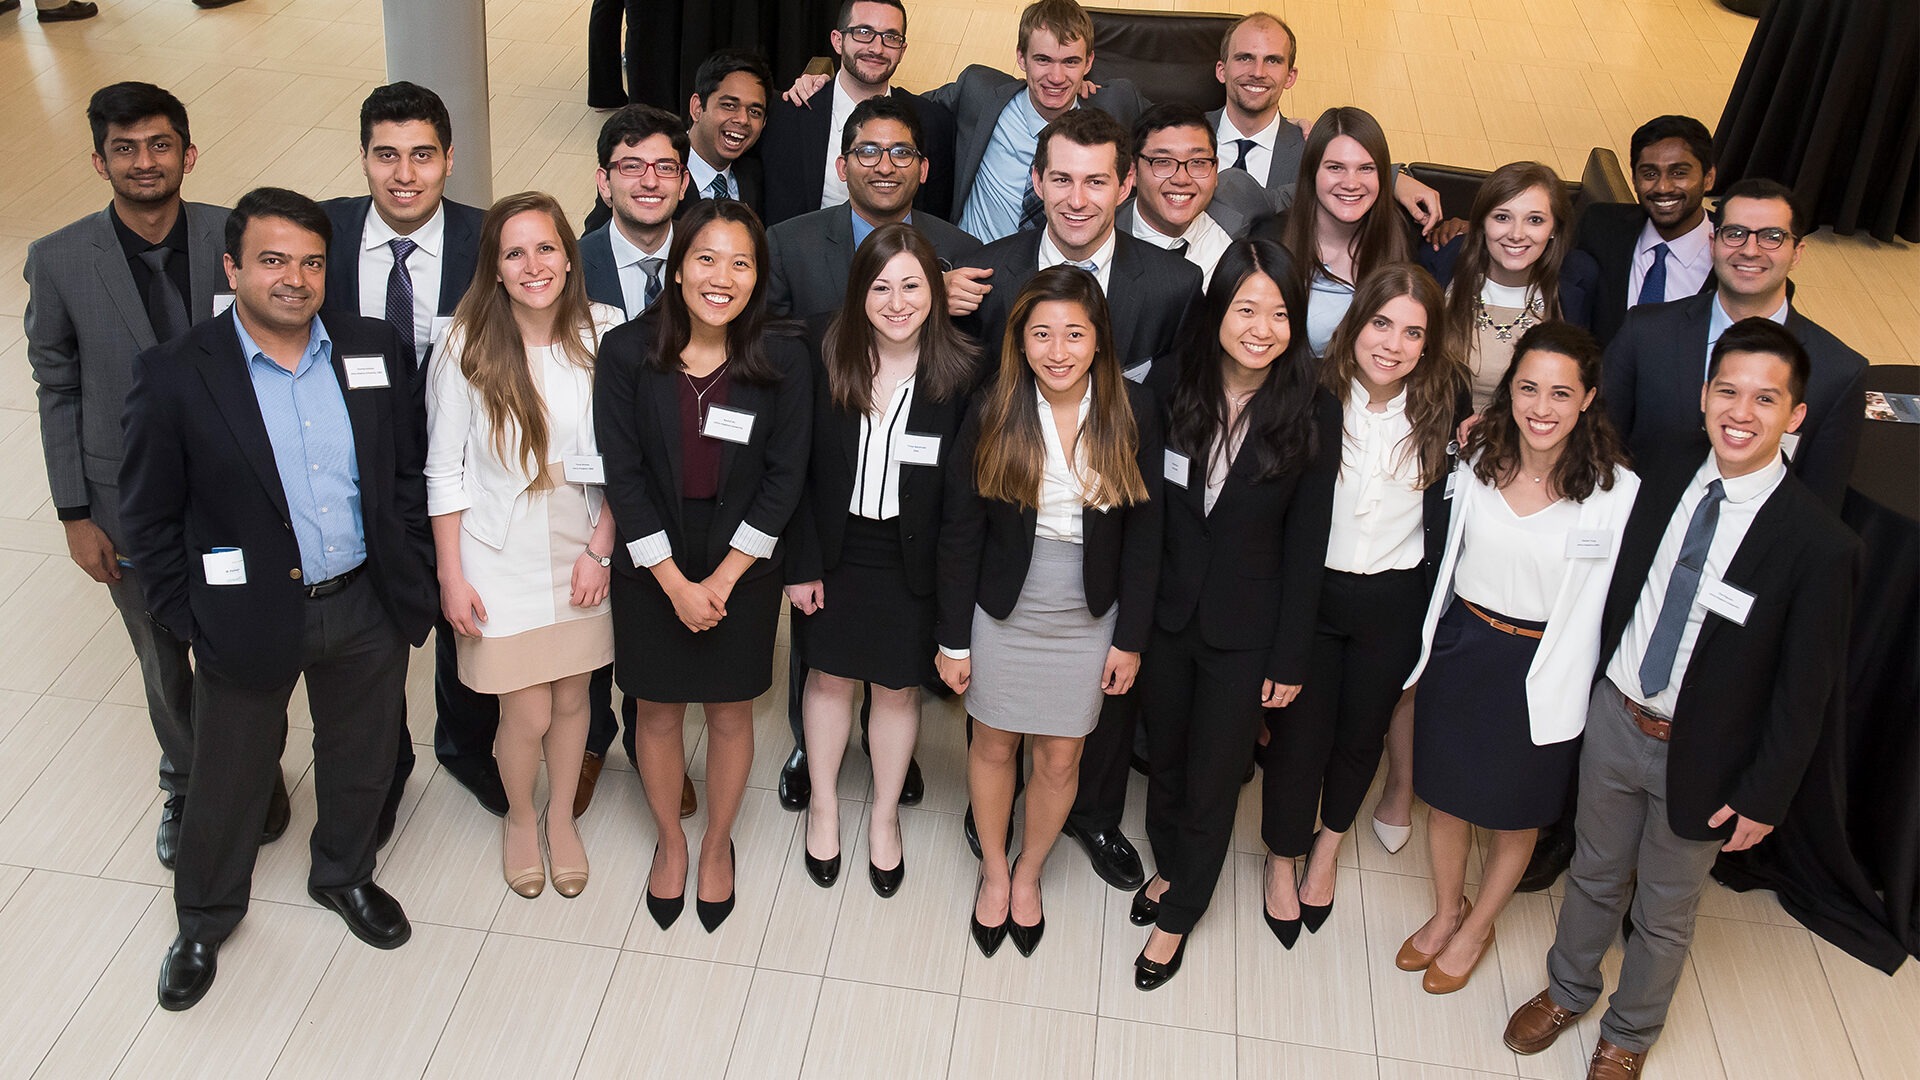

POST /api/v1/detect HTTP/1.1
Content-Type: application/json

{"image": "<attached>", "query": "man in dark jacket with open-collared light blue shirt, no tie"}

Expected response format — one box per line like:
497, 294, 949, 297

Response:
121, 188, 440, 1009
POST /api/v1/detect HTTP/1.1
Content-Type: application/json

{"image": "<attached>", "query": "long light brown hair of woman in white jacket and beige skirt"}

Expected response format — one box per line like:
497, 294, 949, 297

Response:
453, 192, 593, 490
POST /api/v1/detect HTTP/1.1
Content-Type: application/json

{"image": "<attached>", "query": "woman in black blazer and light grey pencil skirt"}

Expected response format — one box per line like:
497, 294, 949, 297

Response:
935, 265, 1162, 955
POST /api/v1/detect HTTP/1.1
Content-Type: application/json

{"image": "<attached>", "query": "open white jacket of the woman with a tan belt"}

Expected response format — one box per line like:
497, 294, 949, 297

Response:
1405, 461, 1640, 746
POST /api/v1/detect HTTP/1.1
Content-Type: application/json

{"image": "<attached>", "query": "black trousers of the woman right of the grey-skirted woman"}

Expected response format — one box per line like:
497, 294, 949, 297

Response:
1136, 619, 1267, 934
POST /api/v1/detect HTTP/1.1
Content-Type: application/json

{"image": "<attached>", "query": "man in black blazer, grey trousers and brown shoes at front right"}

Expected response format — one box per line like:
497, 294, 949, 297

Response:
1505, 317, 1860, 1080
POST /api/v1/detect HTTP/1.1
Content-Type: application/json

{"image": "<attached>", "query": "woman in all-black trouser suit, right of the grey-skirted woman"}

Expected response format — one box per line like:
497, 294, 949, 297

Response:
1131, 240, 1340, 990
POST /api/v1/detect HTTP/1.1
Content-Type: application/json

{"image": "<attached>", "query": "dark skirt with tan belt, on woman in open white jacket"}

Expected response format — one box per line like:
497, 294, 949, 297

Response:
1413, 598, 1580, 828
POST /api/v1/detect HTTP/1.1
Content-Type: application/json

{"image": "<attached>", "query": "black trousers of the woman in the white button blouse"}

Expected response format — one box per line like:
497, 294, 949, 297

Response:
1260, 569, 1427, 857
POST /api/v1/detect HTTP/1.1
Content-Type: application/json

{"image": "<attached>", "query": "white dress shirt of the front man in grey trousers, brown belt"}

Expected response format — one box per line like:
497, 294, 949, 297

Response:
1607, 454, 1788, 717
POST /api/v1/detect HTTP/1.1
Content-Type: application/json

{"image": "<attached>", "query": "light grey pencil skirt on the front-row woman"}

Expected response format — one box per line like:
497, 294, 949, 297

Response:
966, 538, 1119, 738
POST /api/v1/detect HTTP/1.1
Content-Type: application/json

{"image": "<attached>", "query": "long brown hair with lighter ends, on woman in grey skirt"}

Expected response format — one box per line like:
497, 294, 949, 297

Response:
973, 265, 1146, 509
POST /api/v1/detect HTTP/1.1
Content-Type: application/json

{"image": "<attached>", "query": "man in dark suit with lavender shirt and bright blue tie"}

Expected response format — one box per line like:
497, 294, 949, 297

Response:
1574, 115, 1715, 346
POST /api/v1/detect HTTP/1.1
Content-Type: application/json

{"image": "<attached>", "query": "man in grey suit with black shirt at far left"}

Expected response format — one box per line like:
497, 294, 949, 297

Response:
27, 83, 288, 869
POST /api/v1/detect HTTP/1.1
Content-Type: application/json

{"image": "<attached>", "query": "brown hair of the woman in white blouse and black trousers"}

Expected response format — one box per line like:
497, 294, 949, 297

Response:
1321, 263, 1467, 488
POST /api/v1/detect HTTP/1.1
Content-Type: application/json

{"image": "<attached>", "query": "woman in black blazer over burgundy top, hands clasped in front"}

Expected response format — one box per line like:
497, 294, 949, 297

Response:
593, 200, 812, 932
